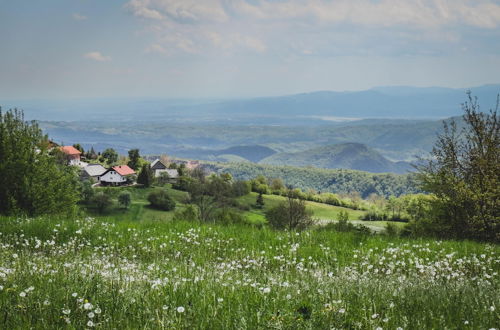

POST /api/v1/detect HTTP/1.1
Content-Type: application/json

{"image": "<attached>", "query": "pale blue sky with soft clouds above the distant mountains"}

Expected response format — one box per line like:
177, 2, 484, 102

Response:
0, 0, 500, 99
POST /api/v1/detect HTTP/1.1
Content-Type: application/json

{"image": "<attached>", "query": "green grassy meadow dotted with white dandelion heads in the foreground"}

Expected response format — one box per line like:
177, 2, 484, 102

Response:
0, 217, 500, 329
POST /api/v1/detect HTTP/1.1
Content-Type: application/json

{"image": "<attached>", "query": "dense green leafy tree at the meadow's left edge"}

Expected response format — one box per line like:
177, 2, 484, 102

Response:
0, 109, 79, 216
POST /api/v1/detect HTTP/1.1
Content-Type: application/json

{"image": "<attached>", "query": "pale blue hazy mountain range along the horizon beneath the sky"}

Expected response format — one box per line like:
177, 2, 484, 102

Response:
4, 84, 500, 125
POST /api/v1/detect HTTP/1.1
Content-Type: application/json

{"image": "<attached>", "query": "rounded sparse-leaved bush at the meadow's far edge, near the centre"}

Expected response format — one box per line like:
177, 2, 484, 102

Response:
266, 195, 314, 230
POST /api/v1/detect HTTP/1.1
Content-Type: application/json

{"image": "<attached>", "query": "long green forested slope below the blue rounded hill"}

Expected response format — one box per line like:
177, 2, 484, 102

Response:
208, 163, 421, 198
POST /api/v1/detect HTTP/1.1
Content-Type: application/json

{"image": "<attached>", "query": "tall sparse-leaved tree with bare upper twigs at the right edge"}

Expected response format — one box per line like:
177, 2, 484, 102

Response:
417, 92, 500, 241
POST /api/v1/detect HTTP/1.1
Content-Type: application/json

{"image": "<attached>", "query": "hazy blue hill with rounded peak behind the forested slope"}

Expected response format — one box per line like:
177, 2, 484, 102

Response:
261, 143, 412, 173
